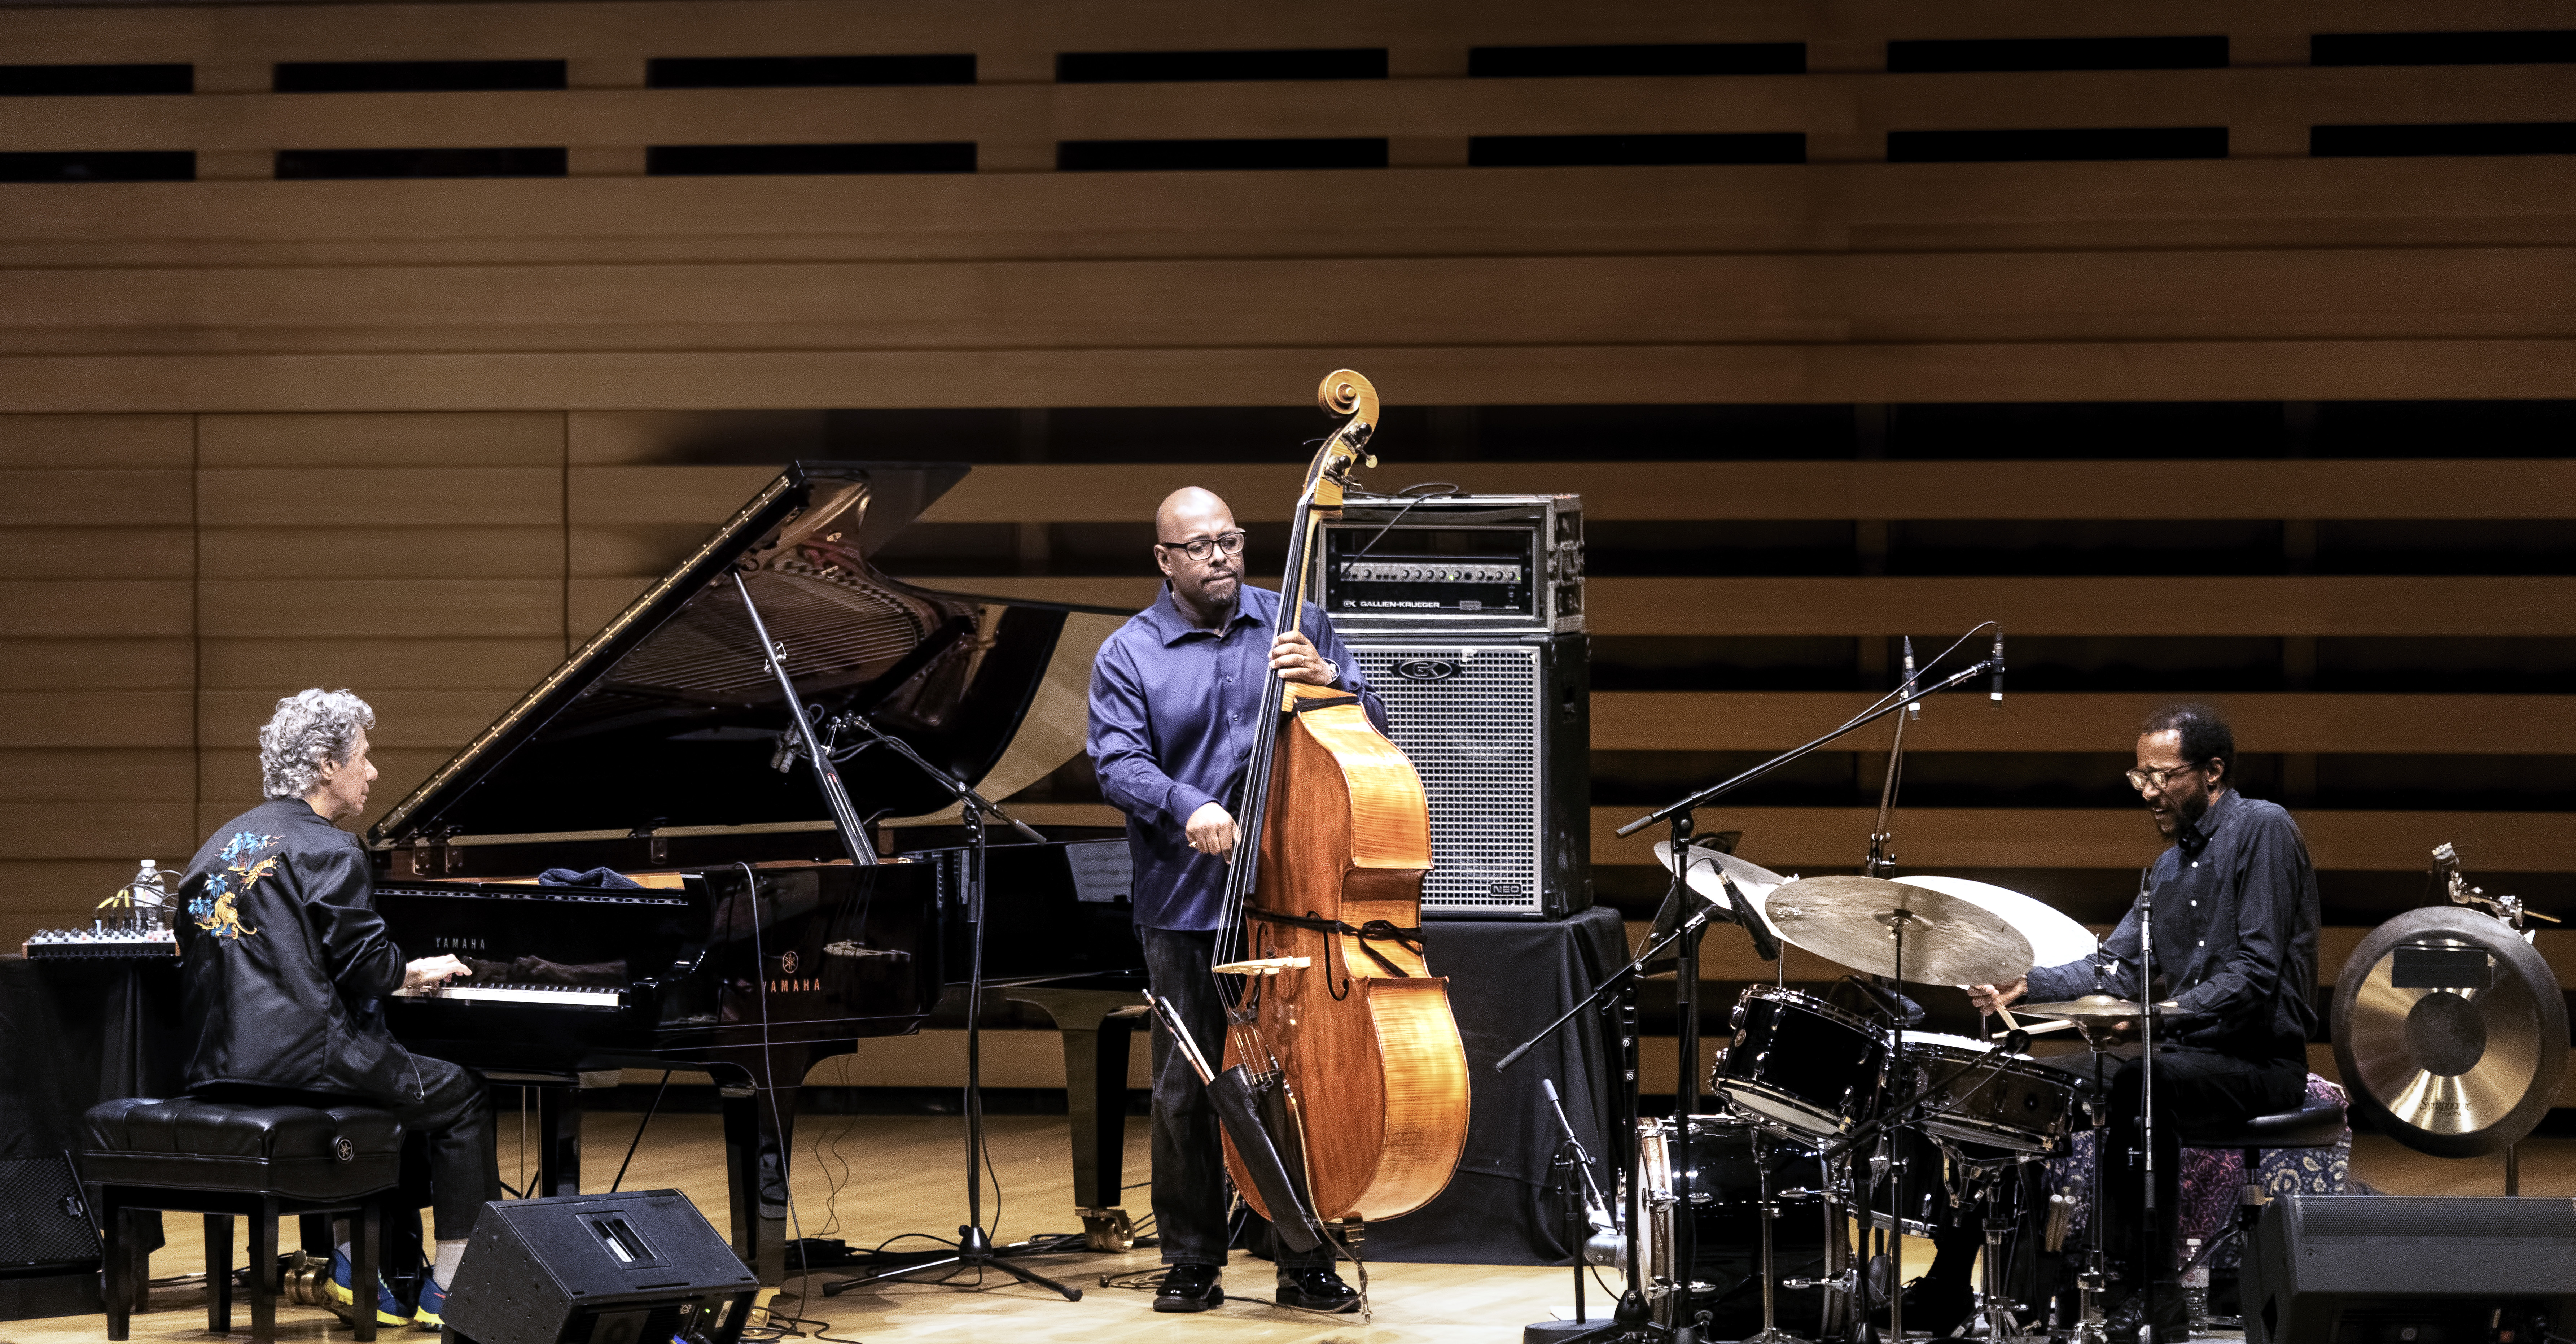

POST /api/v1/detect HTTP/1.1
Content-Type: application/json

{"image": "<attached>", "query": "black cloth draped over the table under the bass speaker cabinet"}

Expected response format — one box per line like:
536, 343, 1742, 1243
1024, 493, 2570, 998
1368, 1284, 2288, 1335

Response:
1360, 909, 1628, 1264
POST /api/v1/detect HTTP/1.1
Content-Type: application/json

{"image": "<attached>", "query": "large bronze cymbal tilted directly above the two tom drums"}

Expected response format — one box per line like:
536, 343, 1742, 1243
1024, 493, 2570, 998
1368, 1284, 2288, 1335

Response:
1762, 878, 2032, 983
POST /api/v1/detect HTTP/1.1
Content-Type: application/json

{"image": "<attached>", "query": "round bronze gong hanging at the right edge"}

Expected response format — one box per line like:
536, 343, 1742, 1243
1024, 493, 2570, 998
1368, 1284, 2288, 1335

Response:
2334, 906, 2568, 1158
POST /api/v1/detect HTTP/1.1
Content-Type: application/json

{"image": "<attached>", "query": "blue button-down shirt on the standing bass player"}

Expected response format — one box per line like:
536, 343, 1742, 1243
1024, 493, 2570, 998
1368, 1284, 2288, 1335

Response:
1085, 584, 1386, 929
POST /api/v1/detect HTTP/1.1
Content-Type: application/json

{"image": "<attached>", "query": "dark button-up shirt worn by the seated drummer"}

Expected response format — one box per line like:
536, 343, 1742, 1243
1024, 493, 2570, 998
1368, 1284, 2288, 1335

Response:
2030, 788, 2318, 1061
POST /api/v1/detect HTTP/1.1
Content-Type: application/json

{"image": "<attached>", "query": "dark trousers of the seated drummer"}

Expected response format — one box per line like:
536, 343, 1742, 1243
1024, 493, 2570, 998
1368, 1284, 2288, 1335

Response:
2094, 1045, 2308, 1290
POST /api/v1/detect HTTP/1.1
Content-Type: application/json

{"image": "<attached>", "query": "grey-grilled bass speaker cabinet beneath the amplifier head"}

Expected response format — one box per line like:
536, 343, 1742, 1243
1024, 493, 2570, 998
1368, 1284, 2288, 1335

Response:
1345, 631, 1592, 919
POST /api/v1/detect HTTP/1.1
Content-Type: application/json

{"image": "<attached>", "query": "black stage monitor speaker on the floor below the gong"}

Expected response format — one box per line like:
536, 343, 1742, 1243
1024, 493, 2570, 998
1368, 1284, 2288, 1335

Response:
2244, 1195, 2576, 1344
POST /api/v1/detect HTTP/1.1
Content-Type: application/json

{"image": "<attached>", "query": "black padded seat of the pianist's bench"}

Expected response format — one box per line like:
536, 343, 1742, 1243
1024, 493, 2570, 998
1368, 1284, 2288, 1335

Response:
80, 1097, 402, 1200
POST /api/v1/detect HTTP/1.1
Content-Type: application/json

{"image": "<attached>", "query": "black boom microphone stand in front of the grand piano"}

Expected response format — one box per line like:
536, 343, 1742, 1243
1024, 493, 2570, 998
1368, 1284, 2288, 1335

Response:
814, 711, 1085, 1303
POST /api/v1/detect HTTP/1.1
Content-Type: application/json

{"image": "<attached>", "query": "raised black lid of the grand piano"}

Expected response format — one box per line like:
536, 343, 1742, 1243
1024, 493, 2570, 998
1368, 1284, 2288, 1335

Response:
368, 461, 1126, 847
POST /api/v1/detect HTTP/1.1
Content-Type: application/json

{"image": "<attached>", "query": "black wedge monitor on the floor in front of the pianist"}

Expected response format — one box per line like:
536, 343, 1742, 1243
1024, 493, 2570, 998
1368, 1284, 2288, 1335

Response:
446, 1190, 760, 1344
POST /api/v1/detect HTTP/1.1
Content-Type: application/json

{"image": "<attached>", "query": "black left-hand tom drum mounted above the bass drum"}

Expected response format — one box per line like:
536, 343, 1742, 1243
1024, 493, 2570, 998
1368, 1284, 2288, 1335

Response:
1708, 983, 1888, 1138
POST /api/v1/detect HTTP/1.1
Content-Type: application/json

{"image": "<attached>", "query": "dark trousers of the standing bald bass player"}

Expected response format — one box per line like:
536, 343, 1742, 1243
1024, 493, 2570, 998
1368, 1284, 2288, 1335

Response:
1136, 929, 1332, 1269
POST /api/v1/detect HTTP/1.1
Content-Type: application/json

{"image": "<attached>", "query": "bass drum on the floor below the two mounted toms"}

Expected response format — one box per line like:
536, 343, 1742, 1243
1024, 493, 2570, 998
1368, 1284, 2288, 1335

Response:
1615, 1115, 1850, 1339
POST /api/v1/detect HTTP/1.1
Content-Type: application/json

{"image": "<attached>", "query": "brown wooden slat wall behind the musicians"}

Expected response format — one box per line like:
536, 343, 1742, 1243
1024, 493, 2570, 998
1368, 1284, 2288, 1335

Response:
0, 0, 2576, 1102
